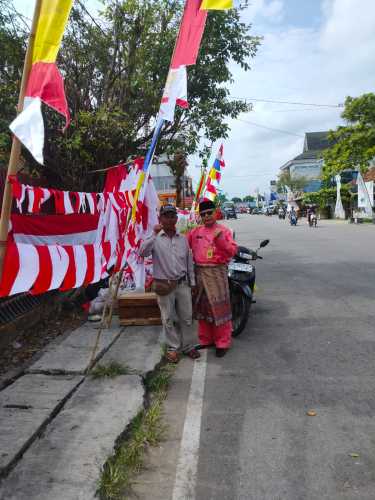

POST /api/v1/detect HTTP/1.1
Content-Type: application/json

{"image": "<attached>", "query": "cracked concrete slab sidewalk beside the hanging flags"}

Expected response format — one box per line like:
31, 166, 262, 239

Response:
0, 321, 162, 500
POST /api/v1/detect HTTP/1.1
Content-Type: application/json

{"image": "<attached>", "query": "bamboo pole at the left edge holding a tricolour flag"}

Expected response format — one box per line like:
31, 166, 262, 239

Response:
0, 0, 43, 279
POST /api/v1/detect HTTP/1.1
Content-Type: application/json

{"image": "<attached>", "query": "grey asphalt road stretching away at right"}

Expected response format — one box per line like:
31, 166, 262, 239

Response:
132, 215, 375, 500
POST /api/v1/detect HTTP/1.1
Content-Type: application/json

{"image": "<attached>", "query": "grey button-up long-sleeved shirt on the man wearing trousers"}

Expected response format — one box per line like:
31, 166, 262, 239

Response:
140, 230, 195, 286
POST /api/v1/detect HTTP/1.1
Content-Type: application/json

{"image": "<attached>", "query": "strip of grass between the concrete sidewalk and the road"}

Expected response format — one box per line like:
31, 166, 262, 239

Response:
98, 365, 175, 500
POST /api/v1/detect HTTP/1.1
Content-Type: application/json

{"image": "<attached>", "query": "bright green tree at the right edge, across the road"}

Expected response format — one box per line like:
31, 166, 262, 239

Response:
323, 93, 375, 180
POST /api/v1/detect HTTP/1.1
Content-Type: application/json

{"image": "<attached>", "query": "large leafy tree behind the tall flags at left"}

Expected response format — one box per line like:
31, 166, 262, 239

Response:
0, 0, 260, 190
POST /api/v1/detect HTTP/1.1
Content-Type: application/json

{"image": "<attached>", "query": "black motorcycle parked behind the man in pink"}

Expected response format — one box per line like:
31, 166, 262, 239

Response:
228, 240, 270, 337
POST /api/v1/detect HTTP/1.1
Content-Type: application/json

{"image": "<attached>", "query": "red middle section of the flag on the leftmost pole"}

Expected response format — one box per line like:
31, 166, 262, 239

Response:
26, 62, 70, 128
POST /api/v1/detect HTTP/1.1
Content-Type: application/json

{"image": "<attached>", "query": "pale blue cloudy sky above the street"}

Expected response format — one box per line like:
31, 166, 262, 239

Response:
16, 0, 375, 197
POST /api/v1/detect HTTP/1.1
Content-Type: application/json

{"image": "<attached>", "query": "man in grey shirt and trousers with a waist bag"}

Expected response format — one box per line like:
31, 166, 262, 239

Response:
140, 205, 200, 363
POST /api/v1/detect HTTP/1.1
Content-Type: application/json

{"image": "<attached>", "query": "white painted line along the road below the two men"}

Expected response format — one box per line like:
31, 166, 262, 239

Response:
172, 349, 207, 500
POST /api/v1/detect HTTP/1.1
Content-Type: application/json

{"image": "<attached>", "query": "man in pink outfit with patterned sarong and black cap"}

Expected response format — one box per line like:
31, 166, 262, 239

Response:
187, 201, 237, 357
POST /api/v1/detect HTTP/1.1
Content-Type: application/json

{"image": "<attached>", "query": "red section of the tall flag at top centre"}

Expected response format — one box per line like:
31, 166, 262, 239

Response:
171, 0, 207, 68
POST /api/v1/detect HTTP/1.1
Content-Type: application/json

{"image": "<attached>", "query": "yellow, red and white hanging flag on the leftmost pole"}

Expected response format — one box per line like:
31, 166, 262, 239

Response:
10, 0, 73, 164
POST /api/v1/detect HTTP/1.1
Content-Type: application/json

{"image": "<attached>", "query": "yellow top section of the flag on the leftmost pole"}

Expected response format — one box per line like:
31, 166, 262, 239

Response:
32, 0, 73, 63
